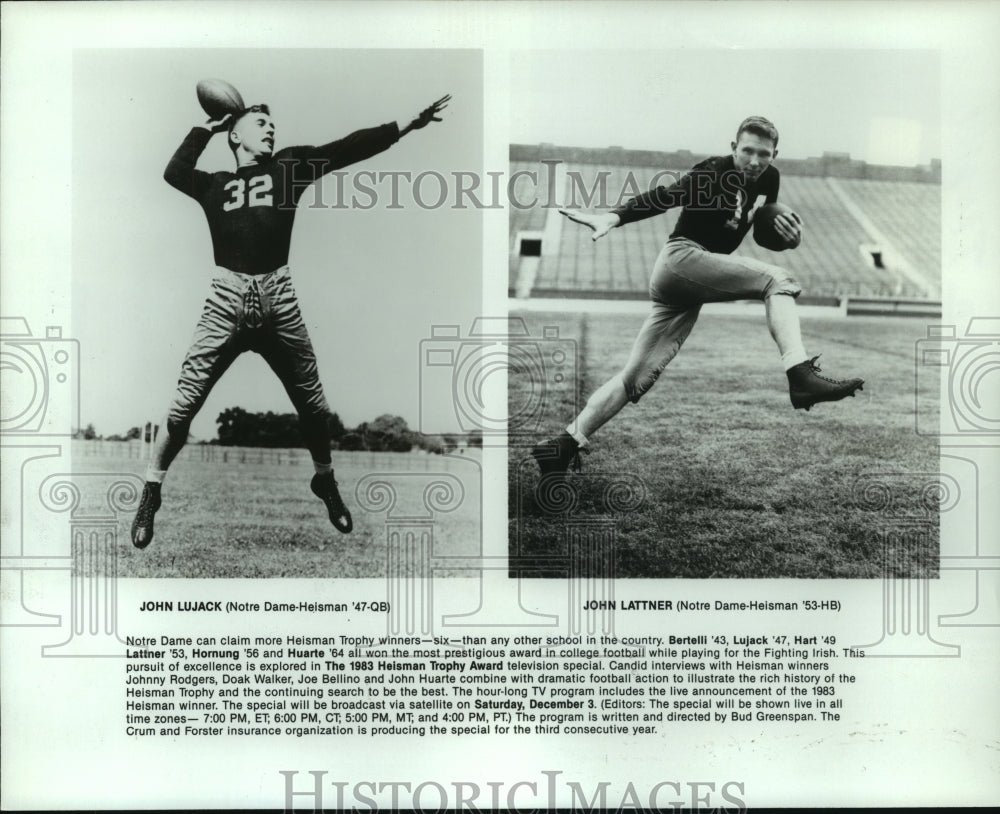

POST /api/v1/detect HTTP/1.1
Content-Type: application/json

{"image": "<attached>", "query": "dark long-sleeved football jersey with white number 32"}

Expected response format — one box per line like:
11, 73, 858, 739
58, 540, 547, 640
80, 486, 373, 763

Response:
163, 123, 399, 274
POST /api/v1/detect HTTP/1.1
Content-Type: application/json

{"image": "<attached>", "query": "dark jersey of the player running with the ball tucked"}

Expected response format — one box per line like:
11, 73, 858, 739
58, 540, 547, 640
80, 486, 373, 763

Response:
614, 155, 781, 254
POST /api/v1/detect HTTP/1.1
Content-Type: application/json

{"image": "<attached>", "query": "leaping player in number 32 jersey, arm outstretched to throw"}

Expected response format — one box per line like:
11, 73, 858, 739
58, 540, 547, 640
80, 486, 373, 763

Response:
132, 96, 451, 548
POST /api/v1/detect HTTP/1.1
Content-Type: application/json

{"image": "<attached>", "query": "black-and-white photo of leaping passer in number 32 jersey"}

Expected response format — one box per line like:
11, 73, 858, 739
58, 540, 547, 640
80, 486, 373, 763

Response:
73, 49, 483, 577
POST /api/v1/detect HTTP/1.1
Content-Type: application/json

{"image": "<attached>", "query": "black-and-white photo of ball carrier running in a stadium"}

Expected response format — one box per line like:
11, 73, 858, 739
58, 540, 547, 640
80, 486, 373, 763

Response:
508, 50, 943, 579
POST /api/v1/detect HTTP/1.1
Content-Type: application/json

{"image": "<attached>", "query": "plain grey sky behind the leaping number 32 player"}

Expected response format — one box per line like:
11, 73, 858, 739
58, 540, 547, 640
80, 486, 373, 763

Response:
72, 49, 483, 446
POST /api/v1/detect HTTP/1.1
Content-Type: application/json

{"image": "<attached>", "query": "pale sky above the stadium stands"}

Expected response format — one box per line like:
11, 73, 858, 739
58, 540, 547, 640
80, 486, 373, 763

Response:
510, 49, 941, 166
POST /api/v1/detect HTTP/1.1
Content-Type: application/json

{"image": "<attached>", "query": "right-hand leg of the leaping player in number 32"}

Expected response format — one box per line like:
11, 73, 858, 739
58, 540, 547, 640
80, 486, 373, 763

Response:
258, 269, 354, 534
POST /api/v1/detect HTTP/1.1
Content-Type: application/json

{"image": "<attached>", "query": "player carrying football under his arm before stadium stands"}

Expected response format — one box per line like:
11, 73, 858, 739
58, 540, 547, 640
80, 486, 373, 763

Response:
532, 116, 864, 474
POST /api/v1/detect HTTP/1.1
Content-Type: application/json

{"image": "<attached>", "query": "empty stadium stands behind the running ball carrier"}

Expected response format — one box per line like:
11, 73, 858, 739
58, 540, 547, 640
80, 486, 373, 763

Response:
509, 145, 941, 313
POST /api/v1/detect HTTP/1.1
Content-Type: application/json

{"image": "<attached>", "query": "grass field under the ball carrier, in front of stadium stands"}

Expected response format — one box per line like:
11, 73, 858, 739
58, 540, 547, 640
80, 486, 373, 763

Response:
509, 308, 939, 578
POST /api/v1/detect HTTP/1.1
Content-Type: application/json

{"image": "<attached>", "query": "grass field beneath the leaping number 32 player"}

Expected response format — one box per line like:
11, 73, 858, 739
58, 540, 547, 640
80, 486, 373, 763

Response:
74, 442, 481, 577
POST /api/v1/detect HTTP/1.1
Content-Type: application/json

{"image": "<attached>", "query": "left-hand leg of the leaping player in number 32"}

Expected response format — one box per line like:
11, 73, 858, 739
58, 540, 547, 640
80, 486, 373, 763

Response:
132, 279, 242, 548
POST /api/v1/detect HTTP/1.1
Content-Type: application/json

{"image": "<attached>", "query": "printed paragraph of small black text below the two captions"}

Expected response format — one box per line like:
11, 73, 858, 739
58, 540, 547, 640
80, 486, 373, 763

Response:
124, 632, 862, 737
